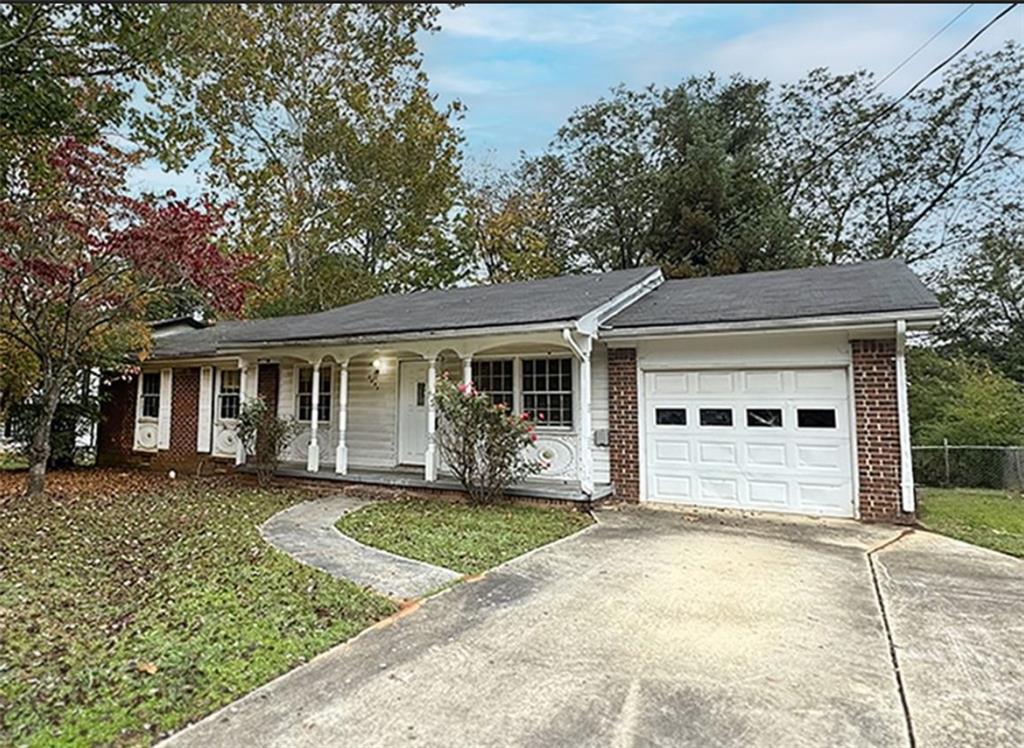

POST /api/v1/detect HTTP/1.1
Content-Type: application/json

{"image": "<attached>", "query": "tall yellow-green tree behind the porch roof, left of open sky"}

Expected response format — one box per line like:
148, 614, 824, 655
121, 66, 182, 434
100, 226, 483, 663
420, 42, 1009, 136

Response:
138, 4, 465, 314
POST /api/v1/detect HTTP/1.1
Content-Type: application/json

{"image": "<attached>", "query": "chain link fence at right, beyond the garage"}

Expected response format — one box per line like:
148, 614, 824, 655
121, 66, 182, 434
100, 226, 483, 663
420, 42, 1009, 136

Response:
911, 444, 1024, 491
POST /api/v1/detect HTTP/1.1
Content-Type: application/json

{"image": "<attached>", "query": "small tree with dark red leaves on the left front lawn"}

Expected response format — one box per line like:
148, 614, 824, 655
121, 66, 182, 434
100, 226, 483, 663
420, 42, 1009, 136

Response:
0, 138, 246, 496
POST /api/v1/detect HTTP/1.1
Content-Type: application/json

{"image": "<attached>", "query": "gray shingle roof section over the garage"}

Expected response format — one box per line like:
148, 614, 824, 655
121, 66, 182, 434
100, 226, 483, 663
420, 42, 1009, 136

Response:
607, 260, 939, 329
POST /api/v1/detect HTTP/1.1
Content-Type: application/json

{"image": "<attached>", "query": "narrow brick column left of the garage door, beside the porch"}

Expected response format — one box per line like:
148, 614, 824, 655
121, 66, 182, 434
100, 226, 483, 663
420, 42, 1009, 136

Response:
608, 348, 640, 501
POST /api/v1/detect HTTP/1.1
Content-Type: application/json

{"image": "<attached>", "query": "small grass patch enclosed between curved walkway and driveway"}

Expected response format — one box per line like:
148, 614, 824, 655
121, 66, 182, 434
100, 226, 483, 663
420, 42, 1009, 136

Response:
338, 499, 591, 574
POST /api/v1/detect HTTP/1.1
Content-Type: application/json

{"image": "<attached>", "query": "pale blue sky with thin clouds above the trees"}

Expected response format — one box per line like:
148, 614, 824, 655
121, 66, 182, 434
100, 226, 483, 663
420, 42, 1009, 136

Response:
132, 3, 1024, 196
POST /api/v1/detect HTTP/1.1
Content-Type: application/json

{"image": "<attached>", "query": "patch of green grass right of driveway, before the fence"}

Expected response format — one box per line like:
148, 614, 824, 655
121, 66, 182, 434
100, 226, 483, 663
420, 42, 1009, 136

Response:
920, 489, 1024, 557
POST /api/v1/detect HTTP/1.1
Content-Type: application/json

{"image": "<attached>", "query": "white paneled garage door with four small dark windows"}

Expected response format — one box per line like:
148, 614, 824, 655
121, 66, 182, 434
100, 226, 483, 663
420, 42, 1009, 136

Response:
644, 369, 853, 516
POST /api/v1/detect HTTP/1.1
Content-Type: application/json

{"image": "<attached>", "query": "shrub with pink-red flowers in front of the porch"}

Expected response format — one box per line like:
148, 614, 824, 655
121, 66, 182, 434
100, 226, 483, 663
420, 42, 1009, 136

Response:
435, 370, 544, 503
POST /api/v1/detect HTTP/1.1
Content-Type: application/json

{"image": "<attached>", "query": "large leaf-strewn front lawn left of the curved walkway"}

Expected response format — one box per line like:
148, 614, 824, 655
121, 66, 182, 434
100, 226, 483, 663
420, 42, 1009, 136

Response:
0, 470, 394, 746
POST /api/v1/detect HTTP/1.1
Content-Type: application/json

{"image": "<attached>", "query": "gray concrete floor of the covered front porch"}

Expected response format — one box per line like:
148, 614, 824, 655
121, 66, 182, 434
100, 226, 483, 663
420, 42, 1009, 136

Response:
251, 462, 611, 503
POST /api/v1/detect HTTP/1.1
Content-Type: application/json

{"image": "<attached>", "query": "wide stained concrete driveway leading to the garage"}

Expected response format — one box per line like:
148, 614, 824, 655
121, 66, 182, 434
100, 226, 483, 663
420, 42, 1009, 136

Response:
163, 509, 1024, 748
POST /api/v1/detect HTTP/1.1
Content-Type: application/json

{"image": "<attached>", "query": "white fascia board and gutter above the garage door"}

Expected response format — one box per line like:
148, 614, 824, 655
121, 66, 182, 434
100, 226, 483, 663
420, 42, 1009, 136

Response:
599, 309, 942, 340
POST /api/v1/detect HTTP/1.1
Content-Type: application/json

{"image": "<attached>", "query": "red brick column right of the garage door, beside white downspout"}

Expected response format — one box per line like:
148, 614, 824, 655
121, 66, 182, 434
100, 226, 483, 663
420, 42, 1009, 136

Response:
850, 340, 913, 523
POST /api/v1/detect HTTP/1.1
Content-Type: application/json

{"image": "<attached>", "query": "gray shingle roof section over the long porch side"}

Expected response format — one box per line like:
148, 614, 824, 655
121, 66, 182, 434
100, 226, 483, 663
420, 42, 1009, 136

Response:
154, 267, 657, 358
